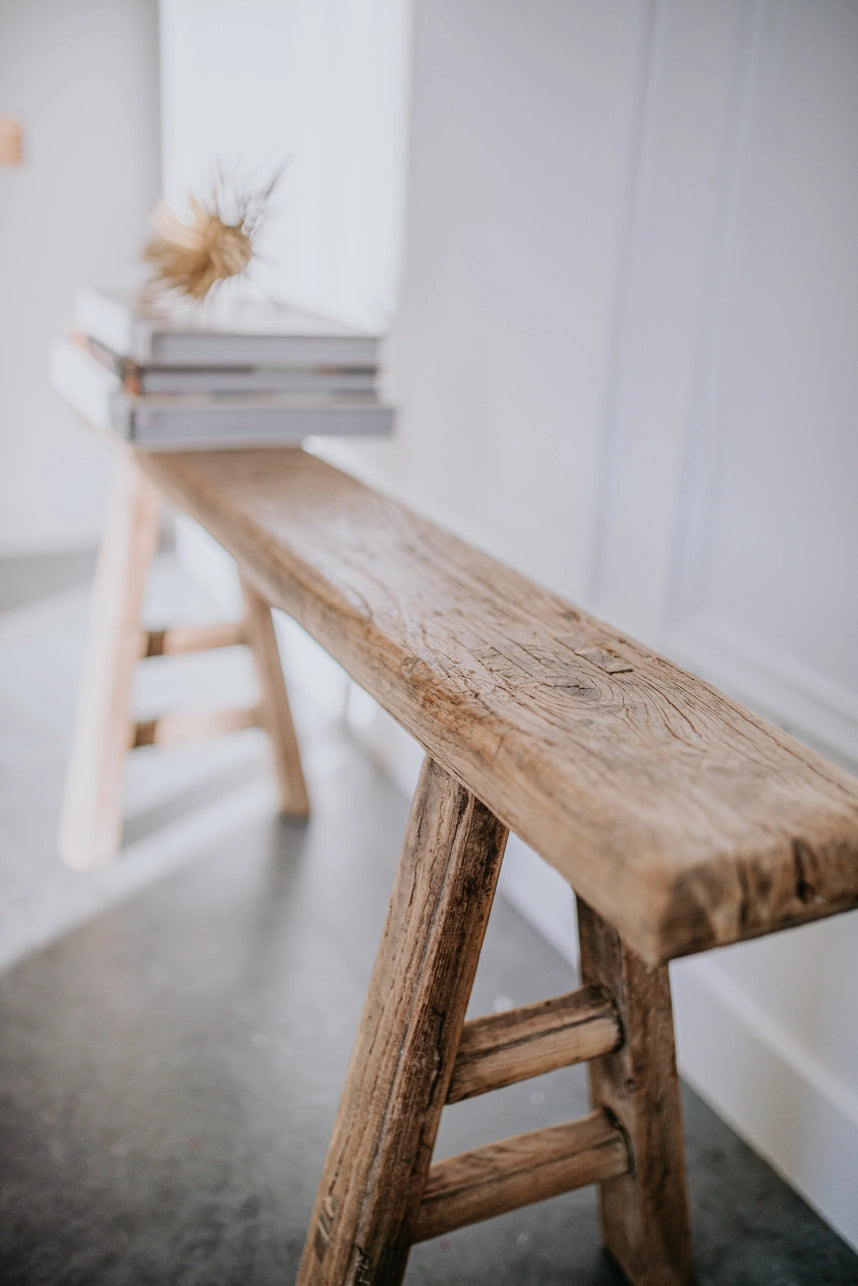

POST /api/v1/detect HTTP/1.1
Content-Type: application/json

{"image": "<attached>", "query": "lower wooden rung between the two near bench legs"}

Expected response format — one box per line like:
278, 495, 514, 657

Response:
413, 1110, 629, 1242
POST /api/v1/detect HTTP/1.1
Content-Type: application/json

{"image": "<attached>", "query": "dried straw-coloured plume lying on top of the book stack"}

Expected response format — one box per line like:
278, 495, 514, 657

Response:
143, 170, 280, 300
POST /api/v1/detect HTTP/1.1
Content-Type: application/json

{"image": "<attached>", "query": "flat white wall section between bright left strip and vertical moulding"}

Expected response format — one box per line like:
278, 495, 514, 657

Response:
331, 3, 648, 593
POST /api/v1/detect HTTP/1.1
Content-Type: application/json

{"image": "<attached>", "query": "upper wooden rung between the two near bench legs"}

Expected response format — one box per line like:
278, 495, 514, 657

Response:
446, 986, 623, 1103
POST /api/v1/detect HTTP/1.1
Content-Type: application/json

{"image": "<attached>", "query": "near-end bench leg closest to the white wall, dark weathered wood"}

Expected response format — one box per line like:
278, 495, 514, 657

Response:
578, 899, 693, 1286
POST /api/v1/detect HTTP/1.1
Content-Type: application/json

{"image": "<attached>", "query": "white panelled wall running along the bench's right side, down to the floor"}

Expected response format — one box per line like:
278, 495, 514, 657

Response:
160, 0, 858, 1245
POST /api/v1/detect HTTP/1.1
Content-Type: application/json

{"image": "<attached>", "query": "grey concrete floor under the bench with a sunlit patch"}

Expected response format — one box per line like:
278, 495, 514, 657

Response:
0, 552, 858, 1286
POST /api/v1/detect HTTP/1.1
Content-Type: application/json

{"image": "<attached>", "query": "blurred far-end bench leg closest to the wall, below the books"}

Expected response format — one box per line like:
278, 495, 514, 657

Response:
239, 576, 310, 817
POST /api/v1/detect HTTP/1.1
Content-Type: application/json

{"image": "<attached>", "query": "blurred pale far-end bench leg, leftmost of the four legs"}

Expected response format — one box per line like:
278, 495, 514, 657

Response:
58, 453, 161, 869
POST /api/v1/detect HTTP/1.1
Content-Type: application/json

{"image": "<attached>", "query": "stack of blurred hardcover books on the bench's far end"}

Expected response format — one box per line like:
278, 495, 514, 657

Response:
50, 291, 392, 451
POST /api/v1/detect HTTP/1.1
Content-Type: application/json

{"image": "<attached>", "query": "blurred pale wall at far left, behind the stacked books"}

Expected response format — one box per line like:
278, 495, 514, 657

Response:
0, 0, 161, 556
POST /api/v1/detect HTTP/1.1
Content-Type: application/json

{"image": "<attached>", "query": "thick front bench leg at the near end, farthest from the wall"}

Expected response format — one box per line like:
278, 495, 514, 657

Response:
298, 759, 507, 1286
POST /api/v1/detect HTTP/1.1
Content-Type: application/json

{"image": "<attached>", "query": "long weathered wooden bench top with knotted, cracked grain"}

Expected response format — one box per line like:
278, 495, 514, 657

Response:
139, 449, 858, 965
